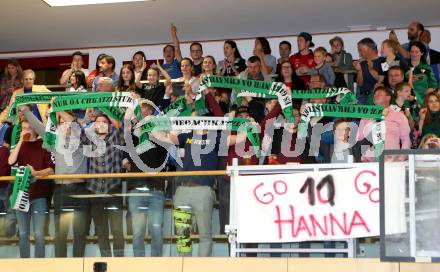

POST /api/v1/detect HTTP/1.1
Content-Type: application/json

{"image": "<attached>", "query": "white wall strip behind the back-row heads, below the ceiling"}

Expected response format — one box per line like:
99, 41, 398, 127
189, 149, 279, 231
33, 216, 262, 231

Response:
0, 27, 440, 71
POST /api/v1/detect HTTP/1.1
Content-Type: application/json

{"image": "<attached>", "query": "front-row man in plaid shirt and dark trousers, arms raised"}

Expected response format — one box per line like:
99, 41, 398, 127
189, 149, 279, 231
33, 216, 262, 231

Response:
60, 112, 128, 257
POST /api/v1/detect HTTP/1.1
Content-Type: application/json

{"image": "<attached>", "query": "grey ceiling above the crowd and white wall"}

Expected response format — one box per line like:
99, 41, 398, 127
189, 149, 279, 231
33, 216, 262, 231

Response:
0, 0, 440, 53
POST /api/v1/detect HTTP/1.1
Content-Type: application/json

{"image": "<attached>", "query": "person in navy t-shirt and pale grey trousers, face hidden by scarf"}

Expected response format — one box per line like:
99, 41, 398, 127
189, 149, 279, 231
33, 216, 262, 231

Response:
150, 113, 246, 257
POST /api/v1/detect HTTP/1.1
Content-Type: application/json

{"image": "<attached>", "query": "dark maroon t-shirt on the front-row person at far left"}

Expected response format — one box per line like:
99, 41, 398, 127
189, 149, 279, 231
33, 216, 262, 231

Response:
17, 139, 55, 199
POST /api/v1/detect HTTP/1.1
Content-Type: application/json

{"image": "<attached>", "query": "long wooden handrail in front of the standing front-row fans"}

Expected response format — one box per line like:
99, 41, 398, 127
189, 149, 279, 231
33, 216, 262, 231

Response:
0, 170, 226, 181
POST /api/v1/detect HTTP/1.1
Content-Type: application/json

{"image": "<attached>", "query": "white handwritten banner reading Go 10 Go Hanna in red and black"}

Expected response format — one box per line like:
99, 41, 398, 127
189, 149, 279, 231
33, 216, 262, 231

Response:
233, 164, 402, 243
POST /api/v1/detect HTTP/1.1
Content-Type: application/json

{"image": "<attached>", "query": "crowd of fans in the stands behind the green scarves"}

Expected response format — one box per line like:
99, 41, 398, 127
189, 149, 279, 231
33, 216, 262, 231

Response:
0, 22, 440, 257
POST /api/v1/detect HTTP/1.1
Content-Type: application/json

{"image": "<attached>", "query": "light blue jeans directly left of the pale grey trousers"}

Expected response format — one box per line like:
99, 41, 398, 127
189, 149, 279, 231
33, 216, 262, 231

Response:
128, 189, 165, 257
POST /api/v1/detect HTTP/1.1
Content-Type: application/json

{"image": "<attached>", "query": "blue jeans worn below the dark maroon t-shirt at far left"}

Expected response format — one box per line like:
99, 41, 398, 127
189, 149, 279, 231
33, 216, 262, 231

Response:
17, 198, 47, 258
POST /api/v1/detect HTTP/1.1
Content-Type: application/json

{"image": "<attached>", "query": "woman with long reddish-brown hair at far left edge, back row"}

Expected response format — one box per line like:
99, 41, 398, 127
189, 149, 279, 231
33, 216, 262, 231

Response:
0, 59, 23, 112
